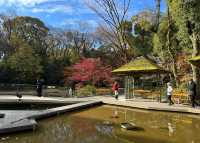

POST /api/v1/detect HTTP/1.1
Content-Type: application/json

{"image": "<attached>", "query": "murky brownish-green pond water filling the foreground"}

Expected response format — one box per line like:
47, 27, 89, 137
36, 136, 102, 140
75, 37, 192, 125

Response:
0, 105, 200, 143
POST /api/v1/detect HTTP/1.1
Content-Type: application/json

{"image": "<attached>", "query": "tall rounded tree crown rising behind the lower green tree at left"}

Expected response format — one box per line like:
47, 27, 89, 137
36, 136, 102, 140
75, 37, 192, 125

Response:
3, 16, 49, 55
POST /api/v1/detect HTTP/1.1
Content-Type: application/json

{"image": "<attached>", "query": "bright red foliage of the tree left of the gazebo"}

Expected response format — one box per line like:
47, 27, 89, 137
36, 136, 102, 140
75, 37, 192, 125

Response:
65, 58, 112, 85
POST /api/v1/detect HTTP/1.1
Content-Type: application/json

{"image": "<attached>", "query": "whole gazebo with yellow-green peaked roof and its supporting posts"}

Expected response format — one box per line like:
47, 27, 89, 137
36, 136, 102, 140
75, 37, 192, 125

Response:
112, 57, 170, 99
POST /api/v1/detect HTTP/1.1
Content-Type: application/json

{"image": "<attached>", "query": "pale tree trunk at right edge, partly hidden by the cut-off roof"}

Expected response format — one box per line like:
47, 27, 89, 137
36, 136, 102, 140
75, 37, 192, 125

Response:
190, 32, 200, 99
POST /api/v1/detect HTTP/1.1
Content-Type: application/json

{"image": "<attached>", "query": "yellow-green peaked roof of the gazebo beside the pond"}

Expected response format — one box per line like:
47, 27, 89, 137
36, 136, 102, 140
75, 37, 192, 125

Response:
112, 57, 169, 75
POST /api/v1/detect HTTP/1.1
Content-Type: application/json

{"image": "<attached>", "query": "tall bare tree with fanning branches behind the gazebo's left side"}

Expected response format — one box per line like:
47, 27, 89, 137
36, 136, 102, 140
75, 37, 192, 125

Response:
86, 0, 131, 63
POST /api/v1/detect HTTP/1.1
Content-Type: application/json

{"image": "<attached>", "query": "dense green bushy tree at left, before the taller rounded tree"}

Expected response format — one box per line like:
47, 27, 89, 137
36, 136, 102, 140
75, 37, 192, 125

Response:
7, 39, 42, 82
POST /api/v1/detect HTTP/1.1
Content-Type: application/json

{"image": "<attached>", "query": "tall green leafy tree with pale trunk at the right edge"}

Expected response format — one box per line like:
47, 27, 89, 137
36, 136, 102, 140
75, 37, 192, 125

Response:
168, 0, 200, 95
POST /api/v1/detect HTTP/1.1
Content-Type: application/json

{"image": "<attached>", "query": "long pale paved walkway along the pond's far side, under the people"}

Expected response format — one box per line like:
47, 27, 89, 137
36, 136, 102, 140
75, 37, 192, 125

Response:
0, 95, 200, 114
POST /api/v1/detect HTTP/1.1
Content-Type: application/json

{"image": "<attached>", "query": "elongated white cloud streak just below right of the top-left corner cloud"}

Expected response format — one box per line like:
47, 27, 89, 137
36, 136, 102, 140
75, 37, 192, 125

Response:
32, 5, 73, 13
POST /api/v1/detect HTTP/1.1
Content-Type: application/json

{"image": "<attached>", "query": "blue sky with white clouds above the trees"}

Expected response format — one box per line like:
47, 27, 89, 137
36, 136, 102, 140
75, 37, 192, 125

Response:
0, 0, 165, 29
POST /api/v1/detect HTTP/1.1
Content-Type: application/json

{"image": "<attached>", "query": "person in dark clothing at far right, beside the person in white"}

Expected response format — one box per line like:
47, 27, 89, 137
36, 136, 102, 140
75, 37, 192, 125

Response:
188, 79, 198, 108
